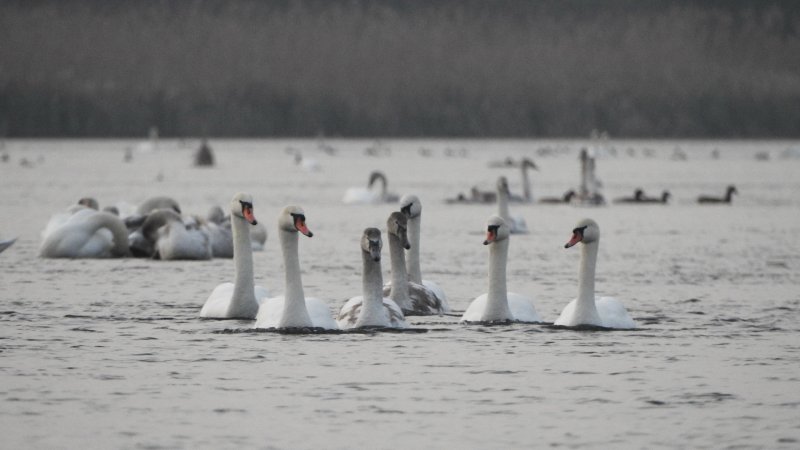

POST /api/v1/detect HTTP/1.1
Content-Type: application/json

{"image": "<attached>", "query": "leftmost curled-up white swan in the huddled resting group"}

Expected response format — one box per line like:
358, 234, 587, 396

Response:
39, 207, 130, 258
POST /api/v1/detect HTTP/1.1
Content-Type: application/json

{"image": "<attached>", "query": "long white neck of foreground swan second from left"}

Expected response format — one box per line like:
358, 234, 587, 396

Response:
278, 230, 314, 328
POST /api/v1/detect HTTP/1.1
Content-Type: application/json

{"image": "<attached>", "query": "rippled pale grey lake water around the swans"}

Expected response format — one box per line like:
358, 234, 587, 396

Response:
0, 140, 800, 448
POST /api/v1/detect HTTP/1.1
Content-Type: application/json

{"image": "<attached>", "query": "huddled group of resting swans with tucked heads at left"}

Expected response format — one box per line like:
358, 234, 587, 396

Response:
39, 197, 267, 260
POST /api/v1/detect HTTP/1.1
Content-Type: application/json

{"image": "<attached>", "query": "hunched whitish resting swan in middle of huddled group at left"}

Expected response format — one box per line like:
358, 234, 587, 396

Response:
138, 209, 212, 260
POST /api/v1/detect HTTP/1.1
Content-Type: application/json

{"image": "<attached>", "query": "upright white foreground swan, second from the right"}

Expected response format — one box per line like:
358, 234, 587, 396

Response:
461, 216, 541, 323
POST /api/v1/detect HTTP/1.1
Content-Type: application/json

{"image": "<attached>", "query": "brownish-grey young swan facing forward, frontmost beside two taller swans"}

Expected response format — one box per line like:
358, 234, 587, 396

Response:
336, 228, 408, 329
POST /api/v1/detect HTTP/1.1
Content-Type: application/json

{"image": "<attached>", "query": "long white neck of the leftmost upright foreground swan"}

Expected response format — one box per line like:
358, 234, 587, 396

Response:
228, 215, 258, 318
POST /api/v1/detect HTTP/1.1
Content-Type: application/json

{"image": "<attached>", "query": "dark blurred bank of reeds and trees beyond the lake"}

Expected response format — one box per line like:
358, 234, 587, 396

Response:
0, 0, 800, 137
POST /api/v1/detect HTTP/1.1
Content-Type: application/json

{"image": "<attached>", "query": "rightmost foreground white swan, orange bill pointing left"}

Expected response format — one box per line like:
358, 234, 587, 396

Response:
554, 219, 636, 329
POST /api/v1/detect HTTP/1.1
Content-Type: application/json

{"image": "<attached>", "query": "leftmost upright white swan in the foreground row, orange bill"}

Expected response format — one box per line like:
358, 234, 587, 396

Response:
200, 193, 269, 319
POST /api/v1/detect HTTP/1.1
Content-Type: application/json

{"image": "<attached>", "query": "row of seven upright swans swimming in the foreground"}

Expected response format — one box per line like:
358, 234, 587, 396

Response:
200, 193, 636, 330
